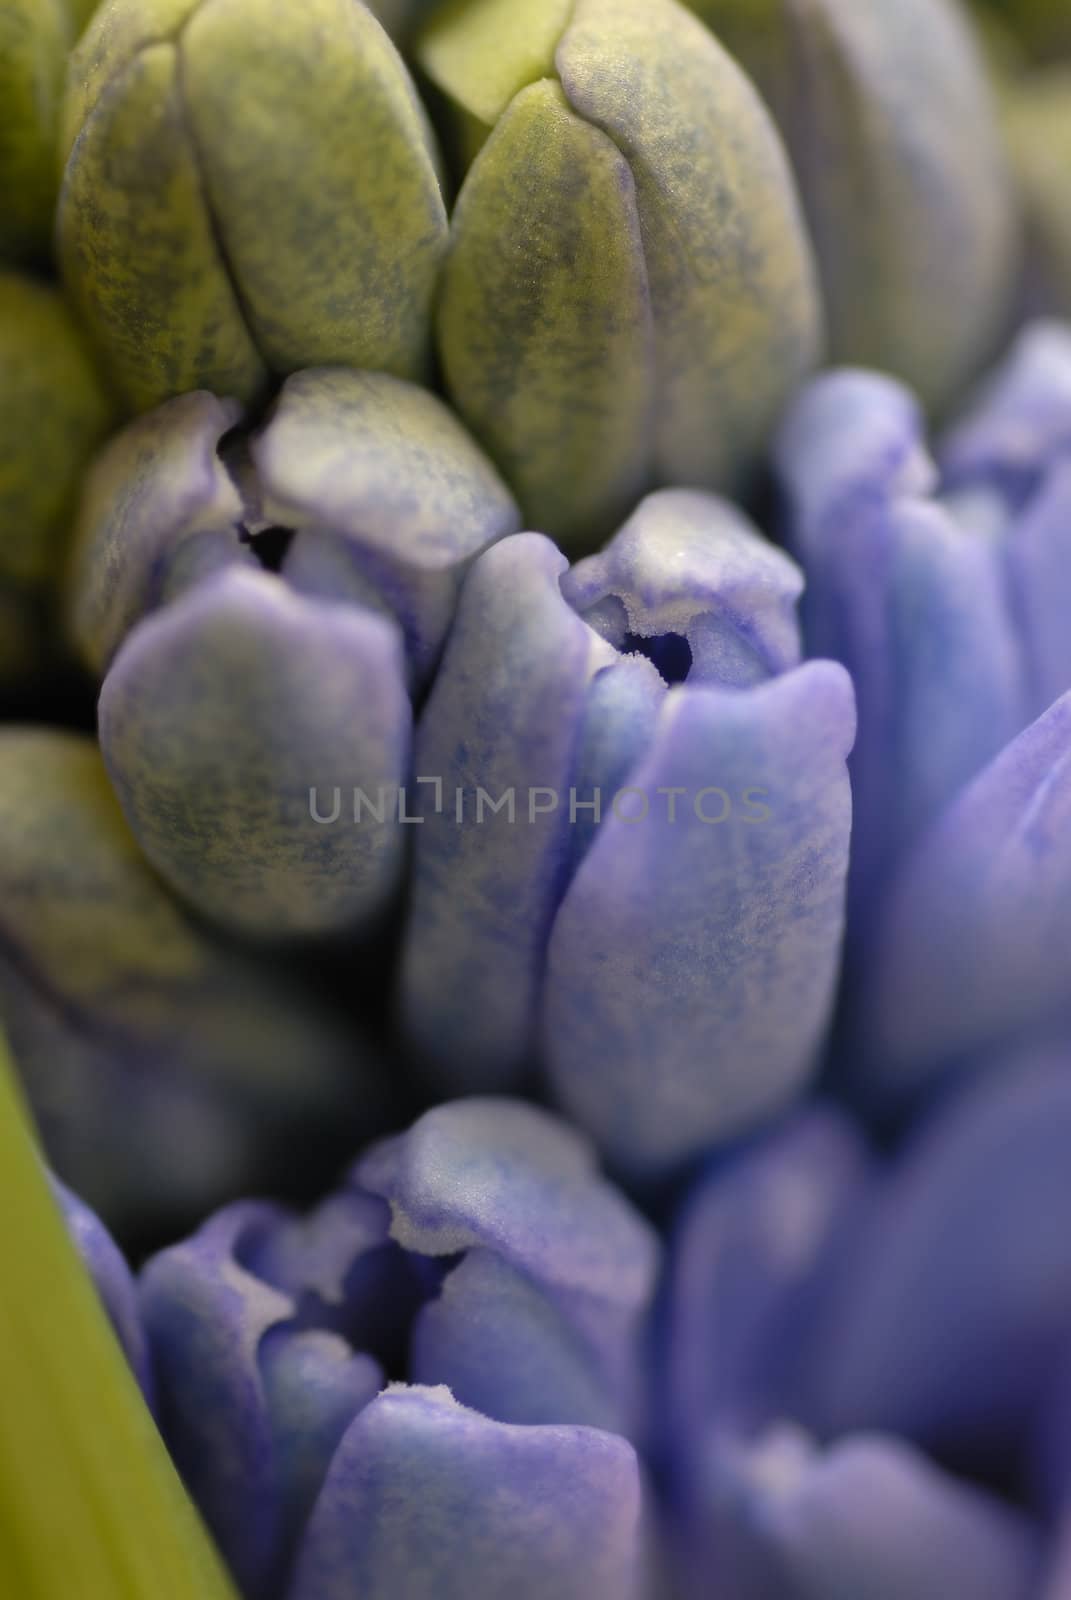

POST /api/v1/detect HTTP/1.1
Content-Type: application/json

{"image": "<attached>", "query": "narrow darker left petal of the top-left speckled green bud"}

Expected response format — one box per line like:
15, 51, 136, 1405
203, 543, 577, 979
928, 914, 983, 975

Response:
58, 43, 267, 411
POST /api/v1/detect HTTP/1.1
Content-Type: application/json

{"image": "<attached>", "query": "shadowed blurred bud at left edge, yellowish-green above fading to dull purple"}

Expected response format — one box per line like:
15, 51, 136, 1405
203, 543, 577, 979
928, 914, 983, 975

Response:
0, 725, 386, 1232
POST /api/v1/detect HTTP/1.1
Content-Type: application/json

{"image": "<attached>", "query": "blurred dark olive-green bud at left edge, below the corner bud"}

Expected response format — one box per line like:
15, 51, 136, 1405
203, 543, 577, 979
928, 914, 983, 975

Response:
0, 270, 112, 691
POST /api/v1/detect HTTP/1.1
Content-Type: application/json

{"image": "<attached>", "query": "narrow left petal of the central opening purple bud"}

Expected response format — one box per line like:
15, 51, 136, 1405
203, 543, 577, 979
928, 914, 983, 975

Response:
399, 534, 613, 1090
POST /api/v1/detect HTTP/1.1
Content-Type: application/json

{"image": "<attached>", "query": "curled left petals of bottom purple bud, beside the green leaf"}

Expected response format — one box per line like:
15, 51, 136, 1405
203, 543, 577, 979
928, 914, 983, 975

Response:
141, 1200, 383, 1600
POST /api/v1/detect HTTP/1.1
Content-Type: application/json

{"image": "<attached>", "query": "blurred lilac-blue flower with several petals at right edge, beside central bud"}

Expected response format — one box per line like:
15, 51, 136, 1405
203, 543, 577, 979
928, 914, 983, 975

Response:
778, 325, 1071, 1098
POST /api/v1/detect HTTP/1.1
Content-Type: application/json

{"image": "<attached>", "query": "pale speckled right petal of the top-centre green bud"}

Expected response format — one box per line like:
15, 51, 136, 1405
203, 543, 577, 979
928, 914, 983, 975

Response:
557, 0, 821, 488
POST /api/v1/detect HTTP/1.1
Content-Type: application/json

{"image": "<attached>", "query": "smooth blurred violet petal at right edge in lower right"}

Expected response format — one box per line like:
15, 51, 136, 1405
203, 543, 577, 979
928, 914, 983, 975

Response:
820, 1049, 1071, 1466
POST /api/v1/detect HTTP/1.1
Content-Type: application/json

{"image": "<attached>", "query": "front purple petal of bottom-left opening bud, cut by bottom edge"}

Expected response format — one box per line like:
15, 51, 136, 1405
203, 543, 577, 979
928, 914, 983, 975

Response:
287, 1387, 640, 1600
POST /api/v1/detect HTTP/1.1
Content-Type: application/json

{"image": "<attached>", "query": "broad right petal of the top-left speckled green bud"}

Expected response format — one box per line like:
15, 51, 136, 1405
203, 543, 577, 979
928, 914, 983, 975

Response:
181, 0, 447, 387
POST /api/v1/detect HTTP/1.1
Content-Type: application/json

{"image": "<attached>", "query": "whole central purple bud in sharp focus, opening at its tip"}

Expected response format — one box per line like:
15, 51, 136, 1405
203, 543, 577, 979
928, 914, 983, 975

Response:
399, 491, 855, 1174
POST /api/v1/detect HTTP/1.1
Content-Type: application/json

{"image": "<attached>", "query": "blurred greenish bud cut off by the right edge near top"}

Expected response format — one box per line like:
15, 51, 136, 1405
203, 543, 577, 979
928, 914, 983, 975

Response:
1005, 67, 1071, 317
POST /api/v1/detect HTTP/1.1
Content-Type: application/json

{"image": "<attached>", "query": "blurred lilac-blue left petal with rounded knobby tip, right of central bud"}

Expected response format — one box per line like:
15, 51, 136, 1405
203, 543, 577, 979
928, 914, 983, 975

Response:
776, 371, 1025, 918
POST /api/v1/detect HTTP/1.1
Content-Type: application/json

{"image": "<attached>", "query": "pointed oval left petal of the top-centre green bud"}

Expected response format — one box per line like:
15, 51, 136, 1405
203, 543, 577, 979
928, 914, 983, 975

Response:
439, 80, 653, 549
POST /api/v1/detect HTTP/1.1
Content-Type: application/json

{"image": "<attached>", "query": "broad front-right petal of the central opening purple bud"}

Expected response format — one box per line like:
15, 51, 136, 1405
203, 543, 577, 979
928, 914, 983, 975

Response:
544, 662, 855, 1171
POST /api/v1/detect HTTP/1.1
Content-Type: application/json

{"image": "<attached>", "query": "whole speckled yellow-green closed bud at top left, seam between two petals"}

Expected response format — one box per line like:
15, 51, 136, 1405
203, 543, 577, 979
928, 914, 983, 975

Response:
58, 0, 447, 410
